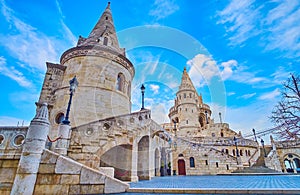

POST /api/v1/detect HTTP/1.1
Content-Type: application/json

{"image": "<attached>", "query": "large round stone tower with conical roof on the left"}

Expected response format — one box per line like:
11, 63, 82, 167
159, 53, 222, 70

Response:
39, 3, 135, 136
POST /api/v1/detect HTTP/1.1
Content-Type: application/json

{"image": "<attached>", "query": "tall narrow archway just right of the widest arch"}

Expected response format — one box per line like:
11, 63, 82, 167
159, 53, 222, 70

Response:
137, 136, 149, 180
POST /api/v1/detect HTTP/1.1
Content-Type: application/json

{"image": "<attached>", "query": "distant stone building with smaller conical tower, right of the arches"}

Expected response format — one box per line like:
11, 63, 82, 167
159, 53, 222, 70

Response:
163, 69, 300, 175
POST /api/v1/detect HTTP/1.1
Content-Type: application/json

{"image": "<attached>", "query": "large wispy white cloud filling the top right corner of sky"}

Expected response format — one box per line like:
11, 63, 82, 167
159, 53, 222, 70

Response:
218, 0, 300, 58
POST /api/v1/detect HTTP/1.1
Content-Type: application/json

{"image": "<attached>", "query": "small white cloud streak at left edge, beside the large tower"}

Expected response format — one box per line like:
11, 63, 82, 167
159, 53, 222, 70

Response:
0, 56, 33, 87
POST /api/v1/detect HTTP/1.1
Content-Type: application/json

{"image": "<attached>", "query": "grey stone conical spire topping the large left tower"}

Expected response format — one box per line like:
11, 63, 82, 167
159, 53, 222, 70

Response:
77, 2, 120, 50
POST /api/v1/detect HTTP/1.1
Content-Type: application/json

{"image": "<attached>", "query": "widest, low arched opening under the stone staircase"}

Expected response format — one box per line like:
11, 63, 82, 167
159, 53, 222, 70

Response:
100, 145, 132, 181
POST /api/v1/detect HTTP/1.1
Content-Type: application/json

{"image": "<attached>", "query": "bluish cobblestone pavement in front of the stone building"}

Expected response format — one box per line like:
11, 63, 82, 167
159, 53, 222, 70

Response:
130, 175, 300, 189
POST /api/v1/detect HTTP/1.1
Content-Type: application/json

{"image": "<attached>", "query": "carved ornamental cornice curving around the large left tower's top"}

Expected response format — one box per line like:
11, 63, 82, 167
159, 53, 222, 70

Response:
60, 45, 135, 77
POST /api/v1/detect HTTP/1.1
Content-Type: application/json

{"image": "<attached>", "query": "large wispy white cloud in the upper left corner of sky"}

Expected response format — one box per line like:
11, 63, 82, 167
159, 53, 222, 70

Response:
0, 1, 76, 71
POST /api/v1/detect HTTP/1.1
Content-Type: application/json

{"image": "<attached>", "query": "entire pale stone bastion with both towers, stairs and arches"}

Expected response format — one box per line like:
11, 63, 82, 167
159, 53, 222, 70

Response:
0, 3, 300, 194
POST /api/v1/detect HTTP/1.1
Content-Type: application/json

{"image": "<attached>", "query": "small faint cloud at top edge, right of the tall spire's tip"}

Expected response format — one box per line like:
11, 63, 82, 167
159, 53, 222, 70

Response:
149, 0, 179, 20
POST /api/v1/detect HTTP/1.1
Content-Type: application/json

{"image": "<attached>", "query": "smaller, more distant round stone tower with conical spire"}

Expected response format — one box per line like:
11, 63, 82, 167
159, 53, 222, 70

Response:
169, 68, 211, 136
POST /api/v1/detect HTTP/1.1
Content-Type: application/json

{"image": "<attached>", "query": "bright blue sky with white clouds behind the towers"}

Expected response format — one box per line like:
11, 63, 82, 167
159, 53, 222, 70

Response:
0, 0, 300, 140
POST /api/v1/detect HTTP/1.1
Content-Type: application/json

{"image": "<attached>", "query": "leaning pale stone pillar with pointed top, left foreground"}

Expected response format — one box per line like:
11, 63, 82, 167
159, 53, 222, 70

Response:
11, 103, 49, 194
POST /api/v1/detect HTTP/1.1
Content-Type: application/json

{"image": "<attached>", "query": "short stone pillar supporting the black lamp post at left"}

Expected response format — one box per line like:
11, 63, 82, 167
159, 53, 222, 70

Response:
55, 124, 71, 155
